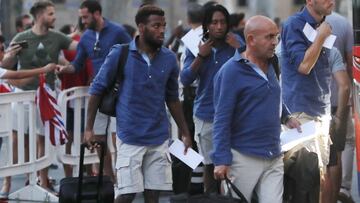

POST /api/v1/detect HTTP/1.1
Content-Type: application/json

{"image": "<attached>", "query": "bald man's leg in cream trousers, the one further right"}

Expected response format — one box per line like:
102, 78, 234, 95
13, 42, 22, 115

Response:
256, 156, 284, 203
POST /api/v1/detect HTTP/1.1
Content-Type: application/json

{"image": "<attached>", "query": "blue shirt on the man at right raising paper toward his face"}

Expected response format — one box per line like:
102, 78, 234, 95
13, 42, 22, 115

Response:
281, 7, 331, 116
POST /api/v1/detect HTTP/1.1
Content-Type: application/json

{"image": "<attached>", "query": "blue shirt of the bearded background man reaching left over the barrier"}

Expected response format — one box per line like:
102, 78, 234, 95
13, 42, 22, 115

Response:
72, 19, 131, 76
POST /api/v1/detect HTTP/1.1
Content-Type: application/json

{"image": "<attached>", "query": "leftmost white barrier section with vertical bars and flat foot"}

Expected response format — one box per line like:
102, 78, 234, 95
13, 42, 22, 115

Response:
0, 91, 58, 202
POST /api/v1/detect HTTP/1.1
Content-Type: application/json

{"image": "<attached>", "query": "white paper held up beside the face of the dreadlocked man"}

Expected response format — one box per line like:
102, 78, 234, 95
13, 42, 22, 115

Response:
181, 26, 203, 56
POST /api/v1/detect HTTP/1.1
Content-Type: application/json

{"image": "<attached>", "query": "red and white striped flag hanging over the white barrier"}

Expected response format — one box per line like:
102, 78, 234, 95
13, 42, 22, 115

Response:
35, 74, 68, 146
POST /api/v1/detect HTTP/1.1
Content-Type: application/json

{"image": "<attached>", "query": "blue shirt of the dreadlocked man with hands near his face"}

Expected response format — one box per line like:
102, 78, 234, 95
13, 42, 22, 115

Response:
180, 43, 242, 122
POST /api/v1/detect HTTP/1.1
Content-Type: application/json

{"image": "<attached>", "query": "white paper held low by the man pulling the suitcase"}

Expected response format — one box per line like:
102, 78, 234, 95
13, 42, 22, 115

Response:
169, 139, 204, 170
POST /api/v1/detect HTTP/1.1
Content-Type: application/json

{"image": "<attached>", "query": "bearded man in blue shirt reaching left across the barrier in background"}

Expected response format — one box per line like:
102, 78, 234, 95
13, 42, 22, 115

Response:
58, 0, 131, 184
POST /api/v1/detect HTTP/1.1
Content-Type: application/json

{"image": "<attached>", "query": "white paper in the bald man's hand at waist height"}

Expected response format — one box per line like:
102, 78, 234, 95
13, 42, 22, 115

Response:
280, 121, 317, 152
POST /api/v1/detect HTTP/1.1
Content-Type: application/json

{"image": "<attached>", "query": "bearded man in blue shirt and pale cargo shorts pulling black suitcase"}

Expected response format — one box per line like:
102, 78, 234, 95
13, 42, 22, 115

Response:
84, 5, 192, 203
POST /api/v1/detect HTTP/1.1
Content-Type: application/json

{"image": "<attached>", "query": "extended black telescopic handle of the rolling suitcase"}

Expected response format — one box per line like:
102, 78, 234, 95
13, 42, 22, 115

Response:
77, 141, 106, 202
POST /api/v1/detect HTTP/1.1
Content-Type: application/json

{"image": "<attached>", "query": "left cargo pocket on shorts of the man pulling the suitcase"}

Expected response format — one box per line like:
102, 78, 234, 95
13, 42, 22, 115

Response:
115, 158, 134, 188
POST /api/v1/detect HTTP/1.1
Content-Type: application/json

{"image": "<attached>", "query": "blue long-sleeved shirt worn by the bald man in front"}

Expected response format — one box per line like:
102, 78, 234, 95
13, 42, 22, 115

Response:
211, 52, 289, 165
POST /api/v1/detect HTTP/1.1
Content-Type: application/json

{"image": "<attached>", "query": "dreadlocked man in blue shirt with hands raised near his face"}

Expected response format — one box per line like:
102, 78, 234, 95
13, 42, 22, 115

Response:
180, 4, 242, 192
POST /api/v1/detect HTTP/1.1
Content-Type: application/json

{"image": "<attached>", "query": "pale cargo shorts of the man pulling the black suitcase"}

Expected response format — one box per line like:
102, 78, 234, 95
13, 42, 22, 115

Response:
116, 139, 172, 195
